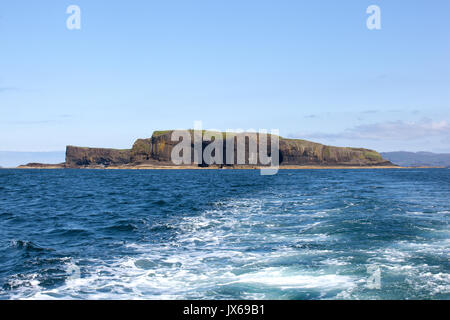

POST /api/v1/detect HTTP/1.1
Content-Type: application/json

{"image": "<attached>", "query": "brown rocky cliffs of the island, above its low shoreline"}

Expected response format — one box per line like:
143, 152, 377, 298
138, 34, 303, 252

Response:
59, 131, 393, 168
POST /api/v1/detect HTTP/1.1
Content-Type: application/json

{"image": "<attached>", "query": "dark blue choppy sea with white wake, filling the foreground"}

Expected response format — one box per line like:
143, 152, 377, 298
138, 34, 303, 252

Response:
0, 169, 450, 299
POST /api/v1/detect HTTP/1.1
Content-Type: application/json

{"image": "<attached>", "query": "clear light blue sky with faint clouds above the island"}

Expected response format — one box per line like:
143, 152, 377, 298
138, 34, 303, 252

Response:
0, 0, 450, 152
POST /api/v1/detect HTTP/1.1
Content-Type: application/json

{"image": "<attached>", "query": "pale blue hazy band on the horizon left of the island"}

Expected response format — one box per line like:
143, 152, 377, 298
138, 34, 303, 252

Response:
0, 151, 66, 168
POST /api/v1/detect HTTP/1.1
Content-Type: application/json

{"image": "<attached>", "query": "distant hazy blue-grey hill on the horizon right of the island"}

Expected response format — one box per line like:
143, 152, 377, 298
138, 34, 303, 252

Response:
381, 151, 450, 167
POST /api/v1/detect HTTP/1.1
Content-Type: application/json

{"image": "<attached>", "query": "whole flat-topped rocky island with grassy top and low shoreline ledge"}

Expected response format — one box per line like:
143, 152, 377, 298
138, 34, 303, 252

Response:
18, 130, 398, 169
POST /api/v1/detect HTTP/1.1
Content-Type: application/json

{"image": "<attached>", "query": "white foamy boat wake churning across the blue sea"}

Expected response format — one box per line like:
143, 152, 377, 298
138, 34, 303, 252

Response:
8, 195, 449, 299
